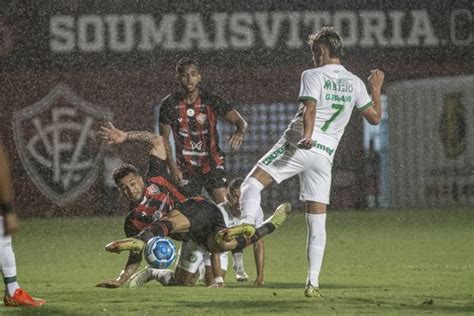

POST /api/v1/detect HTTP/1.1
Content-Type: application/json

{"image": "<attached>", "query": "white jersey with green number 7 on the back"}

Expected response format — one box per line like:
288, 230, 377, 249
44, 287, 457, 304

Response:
284, 64, 372, 161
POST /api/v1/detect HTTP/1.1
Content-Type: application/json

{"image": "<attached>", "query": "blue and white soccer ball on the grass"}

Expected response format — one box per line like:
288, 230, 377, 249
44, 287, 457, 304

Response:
145, 236, 176, 269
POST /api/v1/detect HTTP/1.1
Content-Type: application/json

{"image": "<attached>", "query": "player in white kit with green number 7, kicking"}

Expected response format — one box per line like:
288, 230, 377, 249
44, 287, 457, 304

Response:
228, 27, 384, 297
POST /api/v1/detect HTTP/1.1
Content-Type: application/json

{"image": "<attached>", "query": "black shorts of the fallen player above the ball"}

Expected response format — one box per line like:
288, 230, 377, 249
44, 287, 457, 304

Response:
180, 197, 226, 251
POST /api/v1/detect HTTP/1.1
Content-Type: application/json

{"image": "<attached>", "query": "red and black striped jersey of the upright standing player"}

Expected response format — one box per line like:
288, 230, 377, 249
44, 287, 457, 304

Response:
159, 91, 232, 176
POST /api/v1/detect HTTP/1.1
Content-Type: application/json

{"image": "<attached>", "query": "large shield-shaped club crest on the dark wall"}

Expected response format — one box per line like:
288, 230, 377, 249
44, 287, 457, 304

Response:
13, 84, 113, 206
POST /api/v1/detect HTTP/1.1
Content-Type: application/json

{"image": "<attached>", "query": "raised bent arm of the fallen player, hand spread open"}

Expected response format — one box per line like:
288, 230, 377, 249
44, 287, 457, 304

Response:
99, 122, 166, 160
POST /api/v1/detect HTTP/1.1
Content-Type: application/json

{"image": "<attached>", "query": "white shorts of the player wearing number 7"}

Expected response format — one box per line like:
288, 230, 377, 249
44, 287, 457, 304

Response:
257, 138, 332, 204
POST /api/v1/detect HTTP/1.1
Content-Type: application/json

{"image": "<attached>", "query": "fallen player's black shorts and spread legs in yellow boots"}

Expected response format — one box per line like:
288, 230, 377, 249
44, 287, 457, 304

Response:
105, 197, 291, 284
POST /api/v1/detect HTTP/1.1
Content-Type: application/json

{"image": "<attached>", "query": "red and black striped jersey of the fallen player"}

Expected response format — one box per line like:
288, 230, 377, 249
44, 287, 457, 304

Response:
124, 156, 186, 237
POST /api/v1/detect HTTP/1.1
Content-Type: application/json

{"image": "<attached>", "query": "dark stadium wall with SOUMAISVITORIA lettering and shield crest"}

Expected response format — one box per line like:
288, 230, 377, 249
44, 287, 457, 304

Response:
0, 0, 474, 216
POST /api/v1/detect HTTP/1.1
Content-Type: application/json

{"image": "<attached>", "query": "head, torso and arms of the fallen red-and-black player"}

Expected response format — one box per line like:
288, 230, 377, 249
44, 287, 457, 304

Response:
97, 123, 190, 288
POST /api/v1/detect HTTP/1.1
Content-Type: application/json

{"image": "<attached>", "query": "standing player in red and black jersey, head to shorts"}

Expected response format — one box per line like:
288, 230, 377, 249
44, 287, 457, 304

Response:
159, 58, 247, 204
